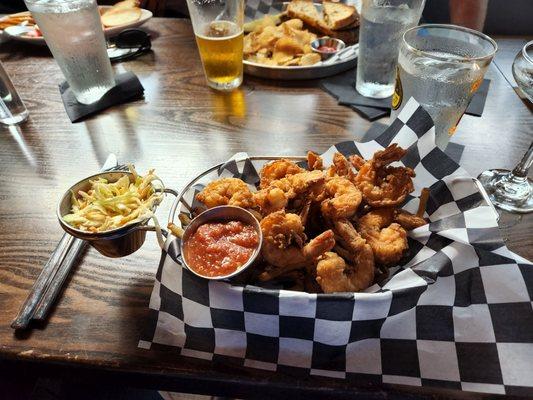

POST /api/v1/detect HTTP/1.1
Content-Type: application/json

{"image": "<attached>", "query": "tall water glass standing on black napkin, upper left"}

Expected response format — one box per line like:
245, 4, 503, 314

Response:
25, 0, 115, 104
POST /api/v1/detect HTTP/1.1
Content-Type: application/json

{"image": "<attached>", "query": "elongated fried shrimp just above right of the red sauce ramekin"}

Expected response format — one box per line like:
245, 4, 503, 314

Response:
254, 170, 325, 215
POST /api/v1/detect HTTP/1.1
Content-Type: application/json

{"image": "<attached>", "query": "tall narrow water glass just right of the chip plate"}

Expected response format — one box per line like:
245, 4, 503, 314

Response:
356, 0, 425, 99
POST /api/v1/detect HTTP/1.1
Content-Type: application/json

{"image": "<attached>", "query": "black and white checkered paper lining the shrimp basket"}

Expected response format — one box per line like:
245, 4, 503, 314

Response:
139, 99, 533, 396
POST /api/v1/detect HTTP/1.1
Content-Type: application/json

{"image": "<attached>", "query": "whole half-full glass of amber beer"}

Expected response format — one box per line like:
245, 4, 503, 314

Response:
187, 0, 244, 91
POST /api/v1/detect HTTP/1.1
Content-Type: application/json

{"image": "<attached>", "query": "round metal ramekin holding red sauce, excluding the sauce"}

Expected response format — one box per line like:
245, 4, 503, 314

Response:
180, 206, 263, 281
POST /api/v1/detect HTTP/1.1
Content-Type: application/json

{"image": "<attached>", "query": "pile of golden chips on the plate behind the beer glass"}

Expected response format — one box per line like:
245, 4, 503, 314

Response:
243, 16, 320, 66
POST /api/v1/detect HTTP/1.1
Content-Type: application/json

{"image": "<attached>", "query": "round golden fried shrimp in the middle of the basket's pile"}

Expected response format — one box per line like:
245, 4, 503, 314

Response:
320, 177, 363, 219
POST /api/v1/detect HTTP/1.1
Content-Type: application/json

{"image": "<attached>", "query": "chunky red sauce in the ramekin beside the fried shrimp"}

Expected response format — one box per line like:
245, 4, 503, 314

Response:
183, 221, 259, 277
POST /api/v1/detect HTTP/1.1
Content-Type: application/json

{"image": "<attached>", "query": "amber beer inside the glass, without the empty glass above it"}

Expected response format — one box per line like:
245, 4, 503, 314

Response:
196, 21, 243, 90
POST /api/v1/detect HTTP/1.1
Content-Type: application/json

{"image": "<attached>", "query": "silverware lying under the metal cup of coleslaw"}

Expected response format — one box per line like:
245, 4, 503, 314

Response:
11, 154, 120, 329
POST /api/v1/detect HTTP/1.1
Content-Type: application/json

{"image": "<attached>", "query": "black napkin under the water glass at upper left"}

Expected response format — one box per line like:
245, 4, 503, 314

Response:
59, 72, 144, 122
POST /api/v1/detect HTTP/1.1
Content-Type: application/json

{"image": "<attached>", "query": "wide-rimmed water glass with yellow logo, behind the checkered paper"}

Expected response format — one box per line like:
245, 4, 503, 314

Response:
392, 24, 498, 150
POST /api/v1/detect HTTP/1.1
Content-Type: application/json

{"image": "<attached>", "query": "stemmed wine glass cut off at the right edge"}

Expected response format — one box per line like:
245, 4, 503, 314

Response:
478, 40, 533, 213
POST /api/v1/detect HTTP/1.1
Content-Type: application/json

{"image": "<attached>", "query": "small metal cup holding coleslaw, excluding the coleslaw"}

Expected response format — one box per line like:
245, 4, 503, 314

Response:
56, 171, 177, 258
